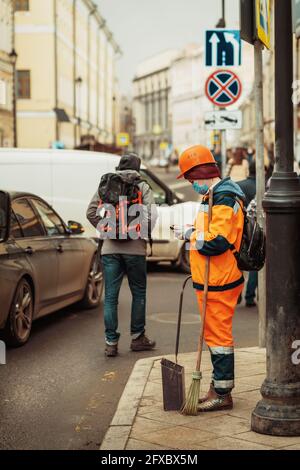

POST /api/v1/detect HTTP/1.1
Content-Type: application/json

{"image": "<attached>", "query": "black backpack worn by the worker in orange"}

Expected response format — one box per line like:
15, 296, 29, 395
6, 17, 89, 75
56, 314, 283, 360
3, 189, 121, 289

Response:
231, 198, 266, 271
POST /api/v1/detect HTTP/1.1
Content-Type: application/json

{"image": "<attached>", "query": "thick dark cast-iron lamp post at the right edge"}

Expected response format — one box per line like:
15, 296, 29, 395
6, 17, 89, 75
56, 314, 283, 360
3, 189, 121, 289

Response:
252, 0, 300, 436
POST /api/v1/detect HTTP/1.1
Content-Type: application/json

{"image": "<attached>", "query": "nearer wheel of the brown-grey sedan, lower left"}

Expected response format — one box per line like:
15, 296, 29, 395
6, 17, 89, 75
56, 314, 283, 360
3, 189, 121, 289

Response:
4, 279, 34, 346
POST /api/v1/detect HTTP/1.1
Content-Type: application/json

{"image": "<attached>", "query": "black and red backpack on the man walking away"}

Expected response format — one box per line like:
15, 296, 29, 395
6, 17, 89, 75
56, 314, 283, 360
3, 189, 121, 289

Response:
98, 173, 143, 241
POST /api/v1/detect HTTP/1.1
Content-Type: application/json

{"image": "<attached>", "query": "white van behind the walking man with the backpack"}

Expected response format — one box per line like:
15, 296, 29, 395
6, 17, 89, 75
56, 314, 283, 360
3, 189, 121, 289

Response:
0, 149, 197, 272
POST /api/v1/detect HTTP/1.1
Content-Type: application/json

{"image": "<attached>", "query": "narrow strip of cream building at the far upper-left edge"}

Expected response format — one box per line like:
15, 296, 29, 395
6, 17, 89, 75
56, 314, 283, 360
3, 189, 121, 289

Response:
0, 0, 14, 147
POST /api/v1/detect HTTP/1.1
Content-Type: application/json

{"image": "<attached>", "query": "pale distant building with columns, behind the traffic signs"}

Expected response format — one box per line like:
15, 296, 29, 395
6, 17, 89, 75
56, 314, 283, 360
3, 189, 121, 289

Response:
133, 40, 255, 159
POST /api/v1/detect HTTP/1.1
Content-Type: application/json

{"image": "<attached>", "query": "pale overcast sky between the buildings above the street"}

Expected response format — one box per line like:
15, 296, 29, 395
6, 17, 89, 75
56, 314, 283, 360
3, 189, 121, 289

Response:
97, 0, 239, 94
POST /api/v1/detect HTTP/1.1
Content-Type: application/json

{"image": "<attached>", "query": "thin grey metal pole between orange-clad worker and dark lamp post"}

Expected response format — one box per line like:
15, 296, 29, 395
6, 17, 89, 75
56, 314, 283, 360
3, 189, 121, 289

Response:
254, 41, 266, 348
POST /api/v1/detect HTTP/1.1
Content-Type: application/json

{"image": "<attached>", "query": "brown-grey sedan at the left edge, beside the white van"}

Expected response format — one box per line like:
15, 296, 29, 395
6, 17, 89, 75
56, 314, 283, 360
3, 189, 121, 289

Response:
0, 191, 103, 346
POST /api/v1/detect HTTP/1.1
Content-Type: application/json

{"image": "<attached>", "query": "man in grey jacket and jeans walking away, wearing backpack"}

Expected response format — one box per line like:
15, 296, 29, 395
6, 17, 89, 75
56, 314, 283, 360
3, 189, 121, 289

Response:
87, 153, 158, 357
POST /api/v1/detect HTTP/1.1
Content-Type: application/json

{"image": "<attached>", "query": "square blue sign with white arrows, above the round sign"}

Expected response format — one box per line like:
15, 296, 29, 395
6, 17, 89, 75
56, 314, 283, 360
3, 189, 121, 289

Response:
205, 29, 242, 67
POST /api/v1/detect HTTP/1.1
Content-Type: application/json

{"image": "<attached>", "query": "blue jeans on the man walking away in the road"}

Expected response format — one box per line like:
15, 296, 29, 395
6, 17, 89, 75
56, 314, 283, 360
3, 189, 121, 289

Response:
102, 254, 147, 344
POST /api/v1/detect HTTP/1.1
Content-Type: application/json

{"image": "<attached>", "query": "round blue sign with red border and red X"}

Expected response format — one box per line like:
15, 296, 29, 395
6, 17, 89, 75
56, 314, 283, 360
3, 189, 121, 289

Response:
205, 70, 242, 108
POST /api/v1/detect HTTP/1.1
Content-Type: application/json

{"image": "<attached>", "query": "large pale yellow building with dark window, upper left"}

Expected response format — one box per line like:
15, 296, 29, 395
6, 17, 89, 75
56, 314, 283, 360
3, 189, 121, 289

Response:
15, 0, 120, 148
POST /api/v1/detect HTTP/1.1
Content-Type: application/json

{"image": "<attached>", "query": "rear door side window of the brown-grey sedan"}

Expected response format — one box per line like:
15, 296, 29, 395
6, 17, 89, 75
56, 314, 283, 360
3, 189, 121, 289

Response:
12, 199, 45, 237
